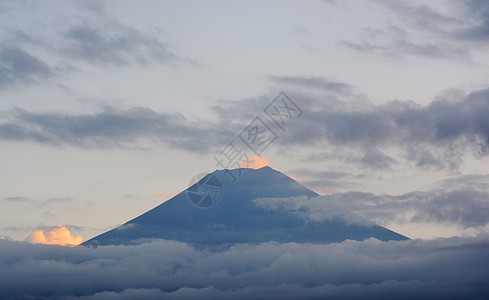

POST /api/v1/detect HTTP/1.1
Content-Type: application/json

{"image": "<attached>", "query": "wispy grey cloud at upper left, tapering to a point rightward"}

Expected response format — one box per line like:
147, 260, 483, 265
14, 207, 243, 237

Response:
54, 2, 197, 67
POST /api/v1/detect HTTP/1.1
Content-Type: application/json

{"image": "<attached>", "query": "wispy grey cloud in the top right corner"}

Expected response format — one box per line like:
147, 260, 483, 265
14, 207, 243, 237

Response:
342, 0, 489, 60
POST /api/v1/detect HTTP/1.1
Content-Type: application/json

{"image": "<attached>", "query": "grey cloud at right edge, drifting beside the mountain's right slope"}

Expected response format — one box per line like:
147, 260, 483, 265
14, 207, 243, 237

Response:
326, 175, 489, 229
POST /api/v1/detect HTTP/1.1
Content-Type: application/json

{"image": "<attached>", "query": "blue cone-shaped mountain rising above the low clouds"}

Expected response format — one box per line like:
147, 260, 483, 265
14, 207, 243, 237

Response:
82, 167, 408, 248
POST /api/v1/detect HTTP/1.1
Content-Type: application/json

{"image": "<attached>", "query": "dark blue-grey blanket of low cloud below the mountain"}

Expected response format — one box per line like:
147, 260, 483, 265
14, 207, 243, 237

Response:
0, 237, 489, 299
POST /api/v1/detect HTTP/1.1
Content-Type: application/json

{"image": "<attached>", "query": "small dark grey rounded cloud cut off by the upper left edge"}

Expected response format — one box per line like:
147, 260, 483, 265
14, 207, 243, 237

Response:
0, 45, 53, 89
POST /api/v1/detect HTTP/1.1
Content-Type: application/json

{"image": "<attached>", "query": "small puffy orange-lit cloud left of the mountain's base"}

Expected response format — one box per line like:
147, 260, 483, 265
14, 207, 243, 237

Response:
25, 225, 83, 246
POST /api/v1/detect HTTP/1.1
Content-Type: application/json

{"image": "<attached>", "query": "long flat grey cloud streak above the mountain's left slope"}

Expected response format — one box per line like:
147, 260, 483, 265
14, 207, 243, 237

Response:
0, 107, 231, 152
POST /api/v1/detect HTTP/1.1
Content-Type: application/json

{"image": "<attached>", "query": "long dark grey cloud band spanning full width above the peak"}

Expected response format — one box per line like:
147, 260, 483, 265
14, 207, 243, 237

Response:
0, 85, 489, 170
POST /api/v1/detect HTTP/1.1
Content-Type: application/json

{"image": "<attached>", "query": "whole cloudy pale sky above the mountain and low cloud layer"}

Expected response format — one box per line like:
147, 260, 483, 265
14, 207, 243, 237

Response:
0, 1, 489, 240
